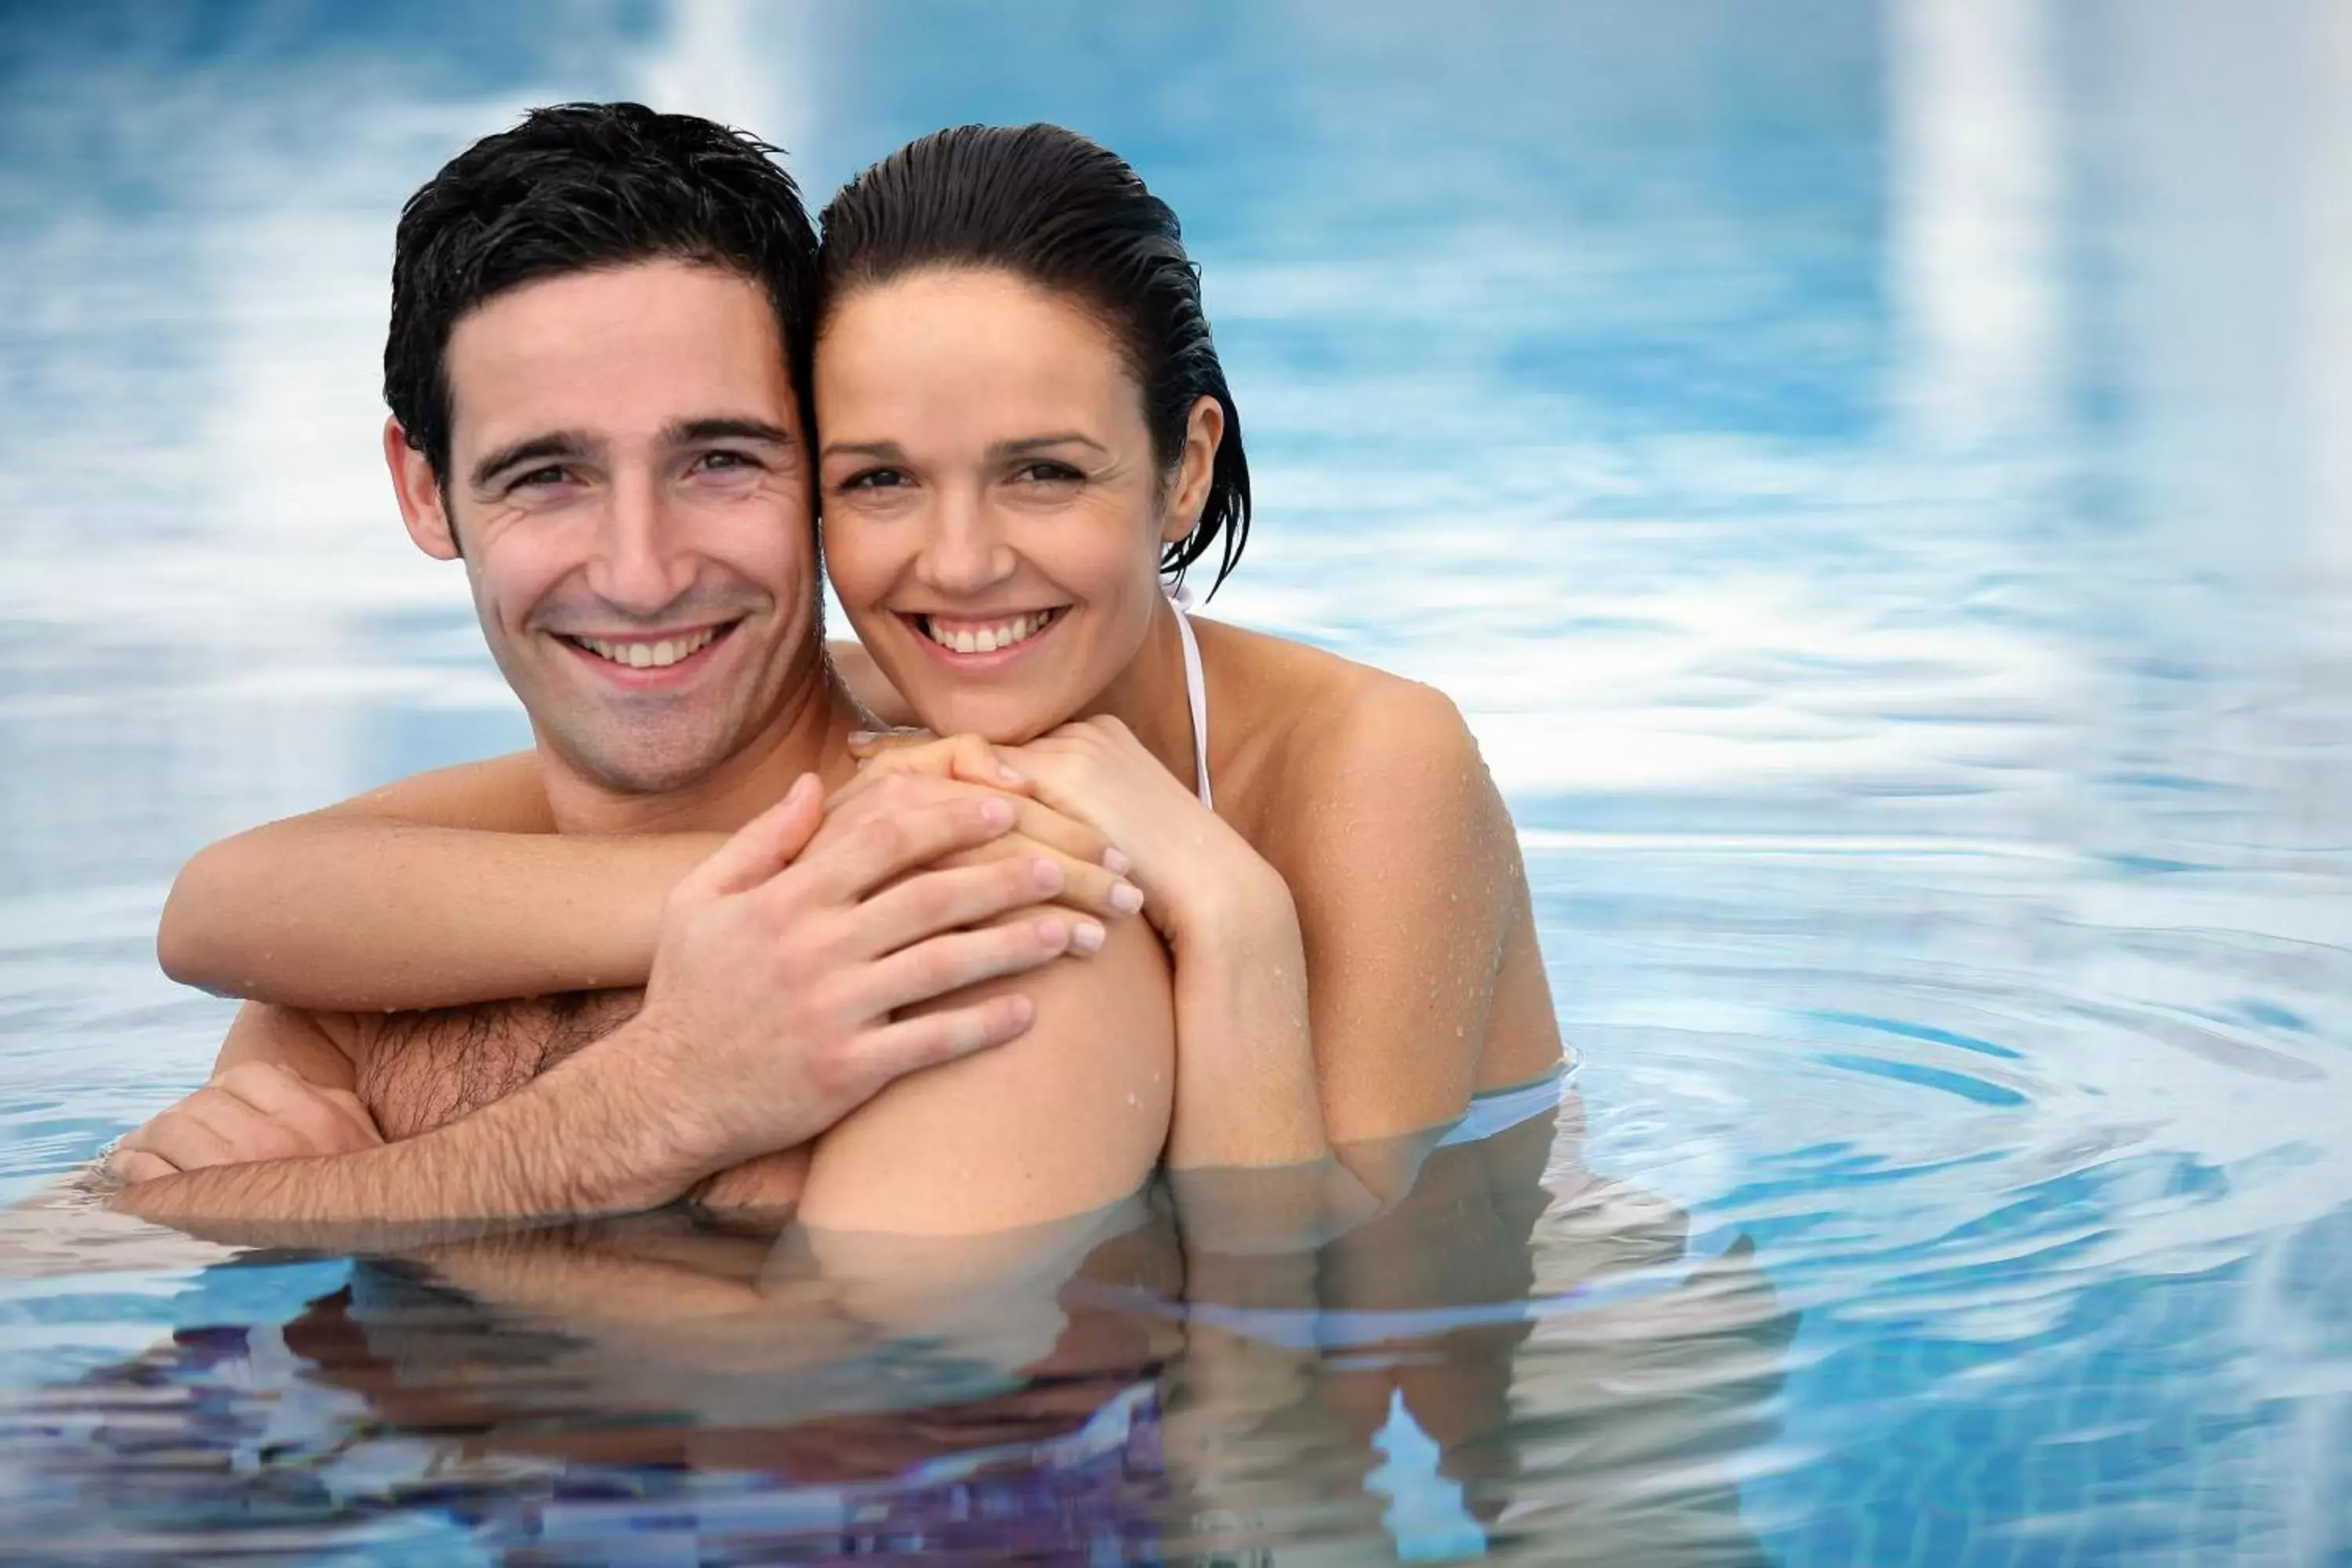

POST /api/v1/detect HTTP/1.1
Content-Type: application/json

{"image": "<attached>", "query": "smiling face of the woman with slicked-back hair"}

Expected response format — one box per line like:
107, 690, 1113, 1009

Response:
816, 268, 1221, 743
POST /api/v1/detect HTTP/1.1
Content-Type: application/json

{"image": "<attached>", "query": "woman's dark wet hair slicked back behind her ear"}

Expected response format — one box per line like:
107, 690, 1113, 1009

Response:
816, 125, 1249, 593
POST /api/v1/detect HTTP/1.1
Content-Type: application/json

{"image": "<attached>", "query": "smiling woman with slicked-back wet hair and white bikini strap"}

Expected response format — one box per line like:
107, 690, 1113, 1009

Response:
167, 127, 1559, 1192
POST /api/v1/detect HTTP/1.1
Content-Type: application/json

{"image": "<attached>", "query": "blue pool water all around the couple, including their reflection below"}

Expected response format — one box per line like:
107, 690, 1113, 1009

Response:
0, 0, 2352, 1568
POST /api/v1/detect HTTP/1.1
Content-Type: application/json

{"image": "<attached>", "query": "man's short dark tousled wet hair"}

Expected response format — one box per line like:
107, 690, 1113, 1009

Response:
383, 103, 816, 485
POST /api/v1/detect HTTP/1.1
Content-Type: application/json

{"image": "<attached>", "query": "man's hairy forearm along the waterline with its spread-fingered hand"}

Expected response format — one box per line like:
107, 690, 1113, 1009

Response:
115, 776, 1103, 1234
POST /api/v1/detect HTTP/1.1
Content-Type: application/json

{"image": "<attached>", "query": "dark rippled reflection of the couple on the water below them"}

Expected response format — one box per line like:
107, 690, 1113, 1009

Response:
0, 1107, 1792, 1563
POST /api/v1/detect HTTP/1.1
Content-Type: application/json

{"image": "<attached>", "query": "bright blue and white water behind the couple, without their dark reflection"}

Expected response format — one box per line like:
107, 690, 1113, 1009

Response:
0, 0, 2352, 1563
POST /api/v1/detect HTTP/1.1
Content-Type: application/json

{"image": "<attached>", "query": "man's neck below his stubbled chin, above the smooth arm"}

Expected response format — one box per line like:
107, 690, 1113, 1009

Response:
539, 668, 858, 832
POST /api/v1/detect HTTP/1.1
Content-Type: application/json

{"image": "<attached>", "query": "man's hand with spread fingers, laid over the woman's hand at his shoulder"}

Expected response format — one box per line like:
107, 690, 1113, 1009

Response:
616, 776, 1103, 1203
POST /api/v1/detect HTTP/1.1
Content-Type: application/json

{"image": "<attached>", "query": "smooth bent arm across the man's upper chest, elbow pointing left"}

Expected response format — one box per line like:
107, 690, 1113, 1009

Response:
155, 753, 722, 1011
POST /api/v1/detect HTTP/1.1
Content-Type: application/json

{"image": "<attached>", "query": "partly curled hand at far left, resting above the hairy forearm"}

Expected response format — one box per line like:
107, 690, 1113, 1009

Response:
106, 1062, 383, 1182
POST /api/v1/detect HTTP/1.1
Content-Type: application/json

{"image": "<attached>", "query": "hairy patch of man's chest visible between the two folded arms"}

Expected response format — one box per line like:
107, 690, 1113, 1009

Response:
355, 989, 644, 1140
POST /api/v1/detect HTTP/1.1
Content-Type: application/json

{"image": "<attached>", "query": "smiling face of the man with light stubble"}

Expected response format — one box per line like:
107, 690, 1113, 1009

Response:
386, 261, 818, 794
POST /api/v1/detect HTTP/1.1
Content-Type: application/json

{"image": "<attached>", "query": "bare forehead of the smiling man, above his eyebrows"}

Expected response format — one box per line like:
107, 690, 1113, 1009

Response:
445, 261, 795, 452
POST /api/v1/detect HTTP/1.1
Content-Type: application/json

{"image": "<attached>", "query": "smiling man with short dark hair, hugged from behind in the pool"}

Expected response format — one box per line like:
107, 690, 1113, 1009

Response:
115, 103, 1174, 1229
